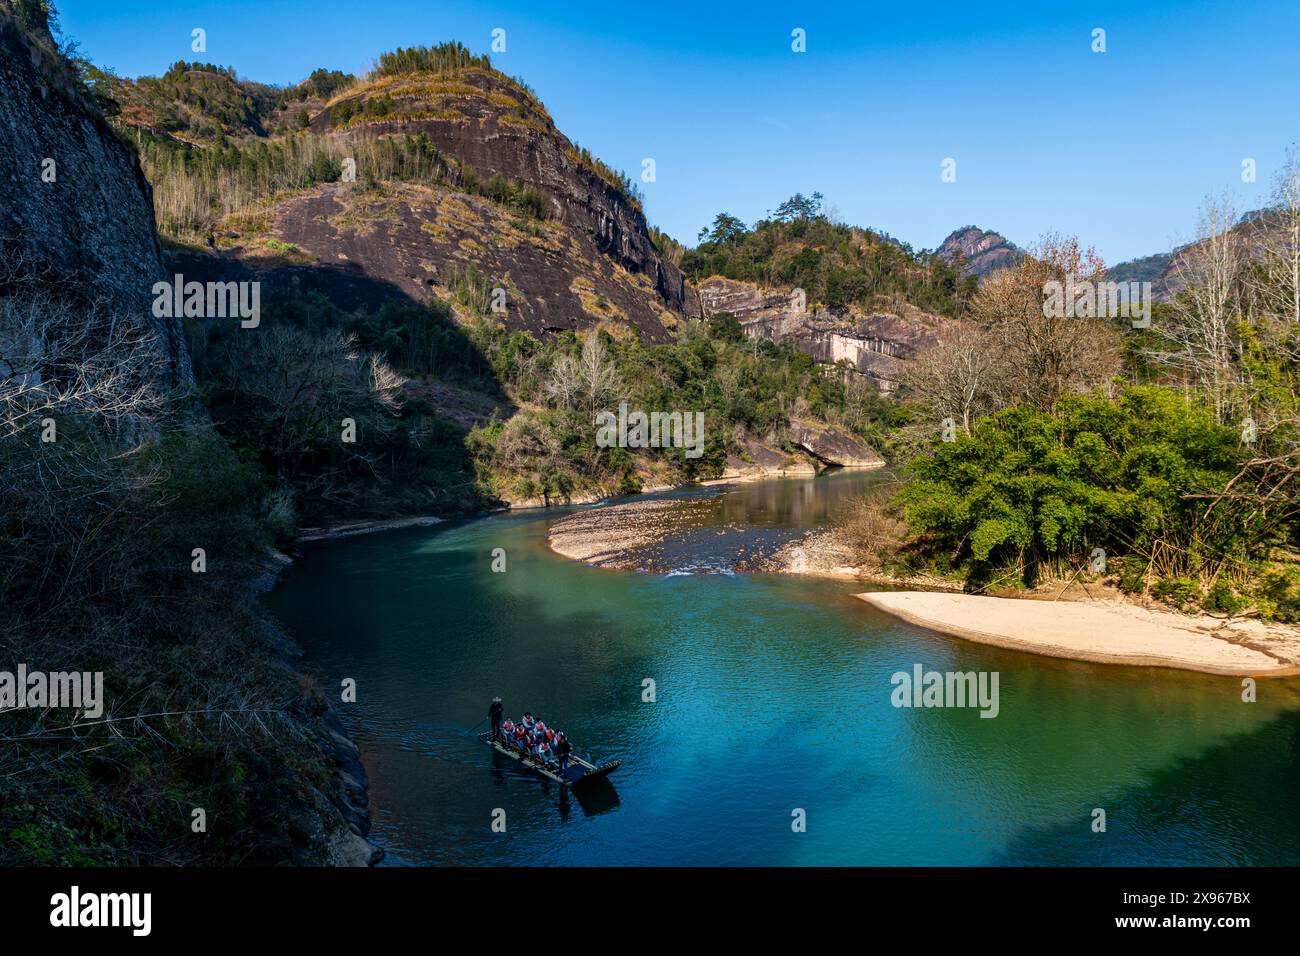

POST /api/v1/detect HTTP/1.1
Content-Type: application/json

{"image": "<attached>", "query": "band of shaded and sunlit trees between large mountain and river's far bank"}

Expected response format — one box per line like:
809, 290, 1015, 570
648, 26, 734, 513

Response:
190, 291, 892, 515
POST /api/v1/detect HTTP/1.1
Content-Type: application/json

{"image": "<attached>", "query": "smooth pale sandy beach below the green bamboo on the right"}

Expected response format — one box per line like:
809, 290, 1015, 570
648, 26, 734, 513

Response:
857, 591, 1300, 676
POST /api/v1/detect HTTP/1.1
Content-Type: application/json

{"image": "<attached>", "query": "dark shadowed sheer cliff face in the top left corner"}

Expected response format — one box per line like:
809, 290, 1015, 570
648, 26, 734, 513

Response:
0, 3, 190, 386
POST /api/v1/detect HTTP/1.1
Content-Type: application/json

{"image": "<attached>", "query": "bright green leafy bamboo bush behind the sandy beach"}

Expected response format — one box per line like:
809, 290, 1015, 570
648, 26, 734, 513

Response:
900, 386, 1255, 589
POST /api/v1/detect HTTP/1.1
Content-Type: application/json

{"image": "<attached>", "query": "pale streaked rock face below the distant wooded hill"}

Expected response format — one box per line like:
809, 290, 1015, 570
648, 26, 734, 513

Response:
699, 276, 956, 393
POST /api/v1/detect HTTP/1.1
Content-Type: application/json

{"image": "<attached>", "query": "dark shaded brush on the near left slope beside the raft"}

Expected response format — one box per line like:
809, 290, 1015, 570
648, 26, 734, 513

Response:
0, 278, 348, 866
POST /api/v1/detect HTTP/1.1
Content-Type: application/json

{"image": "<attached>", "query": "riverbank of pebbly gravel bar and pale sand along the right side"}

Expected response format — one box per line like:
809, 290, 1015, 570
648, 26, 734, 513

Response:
547, 478, 1300, 676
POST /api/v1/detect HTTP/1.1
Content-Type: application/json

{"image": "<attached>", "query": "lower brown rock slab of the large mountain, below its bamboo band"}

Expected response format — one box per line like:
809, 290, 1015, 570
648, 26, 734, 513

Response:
228, 183, 684, 342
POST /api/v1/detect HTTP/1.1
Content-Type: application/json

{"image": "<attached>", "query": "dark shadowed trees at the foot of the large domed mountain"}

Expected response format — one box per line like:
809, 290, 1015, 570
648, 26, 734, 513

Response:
190, 295, 502, 530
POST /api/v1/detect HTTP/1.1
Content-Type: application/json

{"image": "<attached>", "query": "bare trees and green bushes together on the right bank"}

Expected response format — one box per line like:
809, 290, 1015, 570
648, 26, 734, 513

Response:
894, 221, 1300, 620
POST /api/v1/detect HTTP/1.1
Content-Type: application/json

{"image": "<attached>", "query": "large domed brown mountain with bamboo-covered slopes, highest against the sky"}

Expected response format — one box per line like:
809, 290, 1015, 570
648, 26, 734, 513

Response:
112, 44, 696, 341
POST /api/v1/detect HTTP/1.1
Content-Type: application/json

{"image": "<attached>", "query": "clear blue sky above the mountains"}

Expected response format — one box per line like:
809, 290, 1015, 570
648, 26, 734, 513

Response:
56, 0, 1300, 263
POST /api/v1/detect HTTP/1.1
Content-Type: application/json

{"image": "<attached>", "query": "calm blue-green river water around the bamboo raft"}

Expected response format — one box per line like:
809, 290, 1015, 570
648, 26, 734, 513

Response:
269, 473, 1300, 865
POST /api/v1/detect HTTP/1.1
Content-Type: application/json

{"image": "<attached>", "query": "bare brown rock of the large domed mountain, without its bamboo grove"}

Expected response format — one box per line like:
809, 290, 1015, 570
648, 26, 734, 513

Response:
139, 57, 698, 342
